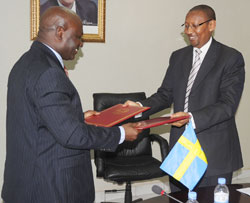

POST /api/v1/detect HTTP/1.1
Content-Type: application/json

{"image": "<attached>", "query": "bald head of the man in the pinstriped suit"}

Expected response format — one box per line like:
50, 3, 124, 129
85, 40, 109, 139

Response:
37, 6, 83, 60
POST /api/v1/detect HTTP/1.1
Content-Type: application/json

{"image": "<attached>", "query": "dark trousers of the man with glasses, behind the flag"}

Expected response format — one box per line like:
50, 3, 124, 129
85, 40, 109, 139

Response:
169, 173, 233, 192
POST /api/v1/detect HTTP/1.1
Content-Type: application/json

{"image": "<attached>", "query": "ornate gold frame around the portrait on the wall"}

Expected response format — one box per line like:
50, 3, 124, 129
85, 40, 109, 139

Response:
30, 0, 106, 42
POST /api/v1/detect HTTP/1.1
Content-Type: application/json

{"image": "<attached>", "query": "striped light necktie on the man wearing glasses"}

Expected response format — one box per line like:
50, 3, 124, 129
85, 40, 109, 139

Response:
184, 49, 201, 112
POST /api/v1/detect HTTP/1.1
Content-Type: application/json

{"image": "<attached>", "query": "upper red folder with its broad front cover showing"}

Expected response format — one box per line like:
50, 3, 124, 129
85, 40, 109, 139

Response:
85, 104, 150, 127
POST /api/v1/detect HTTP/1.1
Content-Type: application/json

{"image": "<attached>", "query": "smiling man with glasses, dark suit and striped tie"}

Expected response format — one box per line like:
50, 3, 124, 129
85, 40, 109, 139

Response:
126, 5, 245, 191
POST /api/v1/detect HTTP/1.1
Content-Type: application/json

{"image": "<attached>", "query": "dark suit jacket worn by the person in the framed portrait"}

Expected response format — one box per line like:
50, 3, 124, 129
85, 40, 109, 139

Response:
40, 0, 97, 25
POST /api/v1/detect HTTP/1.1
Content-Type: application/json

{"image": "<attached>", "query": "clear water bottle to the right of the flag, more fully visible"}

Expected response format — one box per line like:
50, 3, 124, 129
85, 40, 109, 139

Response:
214, 178, 229, 203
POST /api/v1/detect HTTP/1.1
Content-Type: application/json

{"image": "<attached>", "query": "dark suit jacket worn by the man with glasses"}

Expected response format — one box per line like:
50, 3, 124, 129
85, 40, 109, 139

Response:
141, 39, 245, 176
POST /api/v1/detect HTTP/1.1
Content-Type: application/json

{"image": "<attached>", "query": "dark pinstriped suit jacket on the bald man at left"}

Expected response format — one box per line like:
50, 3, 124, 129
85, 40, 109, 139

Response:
2, 41, 120, 203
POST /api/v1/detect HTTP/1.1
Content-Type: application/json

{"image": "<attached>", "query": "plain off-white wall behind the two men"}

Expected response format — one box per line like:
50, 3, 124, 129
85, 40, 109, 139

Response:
0, 0, 250, 201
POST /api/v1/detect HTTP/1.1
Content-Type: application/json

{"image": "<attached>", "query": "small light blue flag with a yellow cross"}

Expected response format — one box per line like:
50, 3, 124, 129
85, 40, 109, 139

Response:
160, 122, 207, 190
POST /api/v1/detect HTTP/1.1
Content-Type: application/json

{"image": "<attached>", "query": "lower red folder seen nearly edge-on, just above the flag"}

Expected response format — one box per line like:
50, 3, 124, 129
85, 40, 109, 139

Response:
137, 116, 190, 130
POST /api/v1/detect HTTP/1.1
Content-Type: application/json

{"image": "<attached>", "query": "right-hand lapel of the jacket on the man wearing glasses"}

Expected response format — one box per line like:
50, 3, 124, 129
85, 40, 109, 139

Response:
190, 39, 218, 94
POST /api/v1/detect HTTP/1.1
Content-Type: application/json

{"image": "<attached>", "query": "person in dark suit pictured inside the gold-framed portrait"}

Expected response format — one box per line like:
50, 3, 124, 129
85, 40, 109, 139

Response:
40, 0, 97, 26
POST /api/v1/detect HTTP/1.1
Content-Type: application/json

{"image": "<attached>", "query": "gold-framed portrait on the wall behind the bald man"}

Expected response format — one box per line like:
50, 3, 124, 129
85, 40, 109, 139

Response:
30, 0, 106, 42
